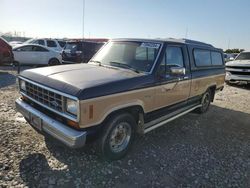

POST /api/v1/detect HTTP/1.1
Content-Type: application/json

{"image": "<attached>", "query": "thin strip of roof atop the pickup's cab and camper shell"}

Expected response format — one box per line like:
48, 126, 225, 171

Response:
112, 38, 214, 48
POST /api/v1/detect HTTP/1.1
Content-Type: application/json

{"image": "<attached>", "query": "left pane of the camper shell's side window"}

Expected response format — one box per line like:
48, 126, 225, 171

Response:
194, 49, 212, 67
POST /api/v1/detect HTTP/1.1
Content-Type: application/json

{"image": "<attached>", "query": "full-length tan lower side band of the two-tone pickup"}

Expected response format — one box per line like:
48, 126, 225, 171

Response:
80, 74, 225, 128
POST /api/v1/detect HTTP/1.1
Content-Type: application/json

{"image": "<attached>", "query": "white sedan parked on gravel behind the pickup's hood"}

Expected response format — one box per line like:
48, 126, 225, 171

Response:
12, 44, 62, 66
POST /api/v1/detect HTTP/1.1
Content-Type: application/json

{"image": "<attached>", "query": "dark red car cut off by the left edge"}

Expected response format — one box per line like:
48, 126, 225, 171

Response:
0, 37, 13, 65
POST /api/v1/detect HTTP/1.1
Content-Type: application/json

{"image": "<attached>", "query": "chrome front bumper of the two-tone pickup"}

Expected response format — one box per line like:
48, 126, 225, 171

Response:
16, 99, 87, 148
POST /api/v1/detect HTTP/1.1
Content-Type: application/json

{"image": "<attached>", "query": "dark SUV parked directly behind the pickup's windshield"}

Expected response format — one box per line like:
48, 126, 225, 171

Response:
62, 41, 104, 63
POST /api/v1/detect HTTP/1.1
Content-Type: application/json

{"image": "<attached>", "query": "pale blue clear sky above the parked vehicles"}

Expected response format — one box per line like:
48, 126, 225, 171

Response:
0, 0, 250, 50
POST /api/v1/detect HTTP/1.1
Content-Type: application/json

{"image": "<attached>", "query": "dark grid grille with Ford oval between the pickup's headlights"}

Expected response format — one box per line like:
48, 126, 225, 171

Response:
26, 82, 63, 112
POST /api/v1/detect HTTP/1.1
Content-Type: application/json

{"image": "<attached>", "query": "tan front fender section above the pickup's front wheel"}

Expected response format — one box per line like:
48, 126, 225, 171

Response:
80, 87, 155, 127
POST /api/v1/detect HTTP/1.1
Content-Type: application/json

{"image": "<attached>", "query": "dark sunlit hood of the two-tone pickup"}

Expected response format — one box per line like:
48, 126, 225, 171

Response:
20, 64, 148, 97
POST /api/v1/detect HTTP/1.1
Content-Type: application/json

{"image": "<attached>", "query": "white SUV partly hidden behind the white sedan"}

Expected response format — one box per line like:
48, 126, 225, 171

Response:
25, 38, 66, 52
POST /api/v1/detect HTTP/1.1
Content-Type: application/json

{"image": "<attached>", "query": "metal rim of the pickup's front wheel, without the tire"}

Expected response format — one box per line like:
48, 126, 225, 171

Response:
109, 122, 131, 153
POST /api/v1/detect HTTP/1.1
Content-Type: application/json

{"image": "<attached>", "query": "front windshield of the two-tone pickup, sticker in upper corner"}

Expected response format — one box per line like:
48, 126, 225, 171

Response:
90, 41, 161, 72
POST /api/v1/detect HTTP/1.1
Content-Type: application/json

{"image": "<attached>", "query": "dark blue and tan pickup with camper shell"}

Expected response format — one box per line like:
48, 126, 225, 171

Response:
16, 39, 225, 160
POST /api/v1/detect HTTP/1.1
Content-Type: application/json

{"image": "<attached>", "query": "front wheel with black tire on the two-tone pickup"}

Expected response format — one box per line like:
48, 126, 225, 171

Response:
97, 113, 136, 161
